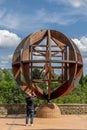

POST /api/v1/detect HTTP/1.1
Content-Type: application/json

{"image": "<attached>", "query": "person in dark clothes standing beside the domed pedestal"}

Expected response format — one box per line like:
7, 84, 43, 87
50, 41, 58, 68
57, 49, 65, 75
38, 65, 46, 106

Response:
26, 93, 36, 126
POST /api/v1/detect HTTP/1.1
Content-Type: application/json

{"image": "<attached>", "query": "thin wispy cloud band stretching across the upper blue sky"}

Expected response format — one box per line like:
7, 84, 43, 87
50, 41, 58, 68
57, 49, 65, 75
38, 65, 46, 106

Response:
0, 5, 76, 31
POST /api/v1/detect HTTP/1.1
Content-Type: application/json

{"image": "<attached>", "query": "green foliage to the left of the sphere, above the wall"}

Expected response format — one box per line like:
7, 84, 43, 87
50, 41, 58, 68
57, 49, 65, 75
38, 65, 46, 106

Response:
0, 69, 25, 104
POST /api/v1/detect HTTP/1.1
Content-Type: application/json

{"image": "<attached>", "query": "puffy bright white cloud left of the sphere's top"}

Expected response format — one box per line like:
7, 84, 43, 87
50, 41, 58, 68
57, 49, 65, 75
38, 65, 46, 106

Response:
0, 30, 21, 48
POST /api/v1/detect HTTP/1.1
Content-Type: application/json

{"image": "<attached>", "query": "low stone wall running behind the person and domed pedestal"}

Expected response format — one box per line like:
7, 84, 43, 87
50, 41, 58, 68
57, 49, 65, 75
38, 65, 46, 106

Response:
0, 104, 87, 115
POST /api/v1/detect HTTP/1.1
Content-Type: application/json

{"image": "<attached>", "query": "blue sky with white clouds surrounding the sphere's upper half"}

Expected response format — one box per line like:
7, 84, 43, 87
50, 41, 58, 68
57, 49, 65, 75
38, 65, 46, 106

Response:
0, 0, 87, 75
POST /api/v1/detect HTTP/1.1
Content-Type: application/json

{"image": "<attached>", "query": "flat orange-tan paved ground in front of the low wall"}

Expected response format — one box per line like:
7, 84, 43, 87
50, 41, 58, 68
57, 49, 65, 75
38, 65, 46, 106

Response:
0, 115, 87, 130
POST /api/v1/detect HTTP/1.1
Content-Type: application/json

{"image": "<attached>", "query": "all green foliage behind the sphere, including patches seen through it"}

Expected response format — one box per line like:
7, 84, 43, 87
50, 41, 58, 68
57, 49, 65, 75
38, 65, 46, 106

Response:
0, 69, 87, 104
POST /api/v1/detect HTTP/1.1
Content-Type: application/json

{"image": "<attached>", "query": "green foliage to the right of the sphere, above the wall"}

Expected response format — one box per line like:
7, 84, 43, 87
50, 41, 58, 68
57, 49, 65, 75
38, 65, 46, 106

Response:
53, 75, 87, 104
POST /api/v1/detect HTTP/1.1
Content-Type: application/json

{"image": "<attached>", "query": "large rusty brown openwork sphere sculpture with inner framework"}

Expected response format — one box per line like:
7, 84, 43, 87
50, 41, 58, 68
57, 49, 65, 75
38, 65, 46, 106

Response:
12, 30, 83, 100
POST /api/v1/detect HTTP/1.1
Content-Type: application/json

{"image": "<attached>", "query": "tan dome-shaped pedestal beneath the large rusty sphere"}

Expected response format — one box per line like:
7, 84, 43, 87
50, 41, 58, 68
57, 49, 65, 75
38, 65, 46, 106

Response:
36, 103, 61, 118
